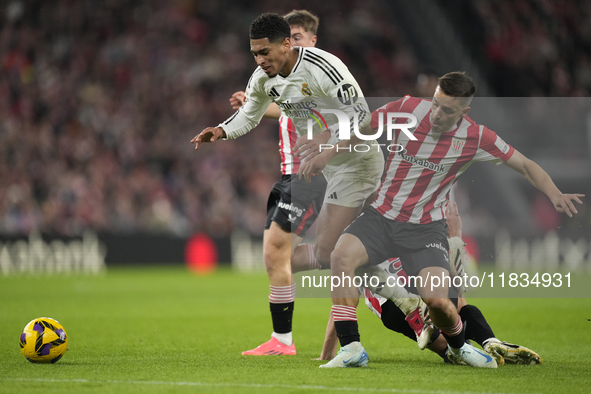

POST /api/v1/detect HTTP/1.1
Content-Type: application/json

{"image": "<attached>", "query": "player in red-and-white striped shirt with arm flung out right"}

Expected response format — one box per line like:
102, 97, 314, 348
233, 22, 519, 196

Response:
323, 72, 583, 368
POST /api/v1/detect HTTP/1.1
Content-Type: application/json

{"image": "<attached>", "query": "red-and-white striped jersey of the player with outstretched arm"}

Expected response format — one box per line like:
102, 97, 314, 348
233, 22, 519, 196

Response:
371, 96, 515, 224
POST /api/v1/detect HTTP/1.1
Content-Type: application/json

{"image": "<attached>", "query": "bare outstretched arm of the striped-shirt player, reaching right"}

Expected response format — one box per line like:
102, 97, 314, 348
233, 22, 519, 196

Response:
505, 150, 585, 217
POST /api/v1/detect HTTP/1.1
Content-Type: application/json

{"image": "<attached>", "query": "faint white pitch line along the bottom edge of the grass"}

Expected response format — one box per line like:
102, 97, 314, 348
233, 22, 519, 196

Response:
0, 378, 509, 394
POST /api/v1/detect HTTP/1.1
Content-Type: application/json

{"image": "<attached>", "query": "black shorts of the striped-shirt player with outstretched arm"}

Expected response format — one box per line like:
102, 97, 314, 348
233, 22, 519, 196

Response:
344, 207, 450, 276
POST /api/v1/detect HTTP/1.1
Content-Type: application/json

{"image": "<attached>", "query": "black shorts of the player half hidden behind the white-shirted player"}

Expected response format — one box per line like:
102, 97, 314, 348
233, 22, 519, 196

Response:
265, 175, 326, 237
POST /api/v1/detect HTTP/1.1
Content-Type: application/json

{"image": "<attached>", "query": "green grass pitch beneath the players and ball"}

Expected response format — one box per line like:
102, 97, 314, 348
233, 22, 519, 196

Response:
0, 268, 591, 394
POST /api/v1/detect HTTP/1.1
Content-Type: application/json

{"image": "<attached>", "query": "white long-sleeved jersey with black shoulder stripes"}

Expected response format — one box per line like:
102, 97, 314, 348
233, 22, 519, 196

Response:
219, 48, 381, 170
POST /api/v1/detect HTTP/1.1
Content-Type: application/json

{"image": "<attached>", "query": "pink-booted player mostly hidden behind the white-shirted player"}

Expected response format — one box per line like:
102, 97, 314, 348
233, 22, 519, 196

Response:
230, 10, 326, 356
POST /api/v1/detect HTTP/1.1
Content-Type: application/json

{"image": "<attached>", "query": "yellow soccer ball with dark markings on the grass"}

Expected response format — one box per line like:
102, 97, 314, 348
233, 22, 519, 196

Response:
20, 317, 68, 363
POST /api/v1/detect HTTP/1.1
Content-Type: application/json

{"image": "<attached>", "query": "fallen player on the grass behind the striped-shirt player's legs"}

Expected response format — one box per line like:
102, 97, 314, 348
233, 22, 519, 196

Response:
319, 203, 542, 366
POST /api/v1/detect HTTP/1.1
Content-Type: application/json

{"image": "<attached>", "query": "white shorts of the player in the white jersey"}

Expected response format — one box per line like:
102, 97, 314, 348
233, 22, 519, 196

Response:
323, 148, 384, 208
